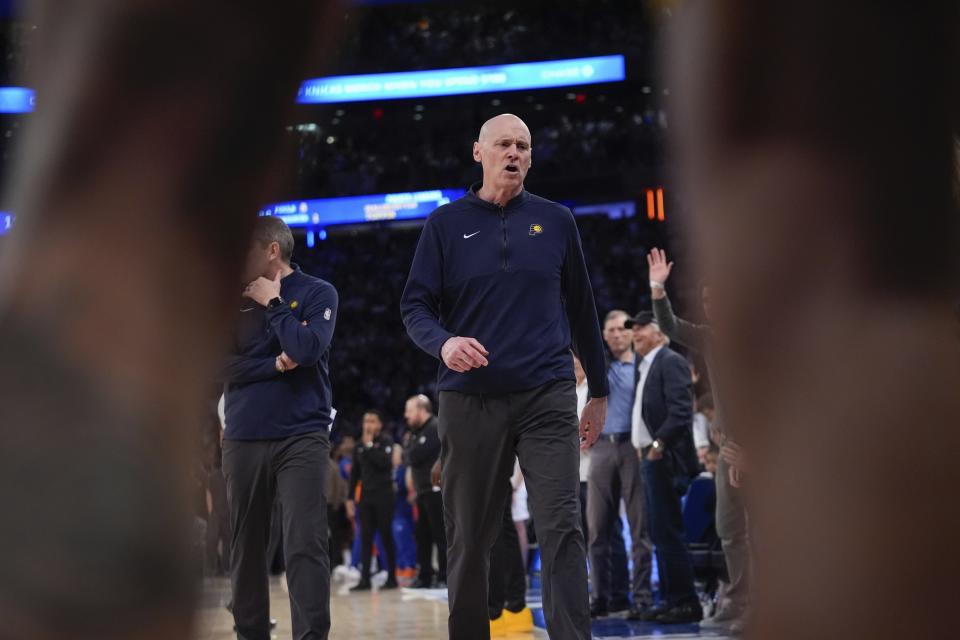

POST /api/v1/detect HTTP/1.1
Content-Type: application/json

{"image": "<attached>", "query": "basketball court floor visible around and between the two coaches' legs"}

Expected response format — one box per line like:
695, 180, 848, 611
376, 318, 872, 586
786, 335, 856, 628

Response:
196, 578, 729, 640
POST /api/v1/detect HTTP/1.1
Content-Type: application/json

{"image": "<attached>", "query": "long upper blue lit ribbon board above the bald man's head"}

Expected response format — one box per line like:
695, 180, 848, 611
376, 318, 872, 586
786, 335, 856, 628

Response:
297, 55, 626, 104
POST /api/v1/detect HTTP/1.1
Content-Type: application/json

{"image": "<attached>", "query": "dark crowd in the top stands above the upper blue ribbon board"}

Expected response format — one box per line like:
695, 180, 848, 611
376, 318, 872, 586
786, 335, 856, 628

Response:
333, 0, 657, 73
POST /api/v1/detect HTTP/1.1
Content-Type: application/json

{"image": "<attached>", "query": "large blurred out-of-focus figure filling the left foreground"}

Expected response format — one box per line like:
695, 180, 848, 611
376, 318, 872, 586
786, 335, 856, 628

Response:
0, 0, 330, 640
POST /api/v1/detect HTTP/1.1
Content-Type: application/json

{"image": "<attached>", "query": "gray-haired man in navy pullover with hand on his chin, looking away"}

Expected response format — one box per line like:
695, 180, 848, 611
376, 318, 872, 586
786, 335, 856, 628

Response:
223, 217, 338, 640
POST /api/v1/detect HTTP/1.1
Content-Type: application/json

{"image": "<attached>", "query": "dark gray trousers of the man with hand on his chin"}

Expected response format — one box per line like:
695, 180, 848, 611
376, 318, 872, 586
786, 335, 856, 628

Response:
223, 431, 330, 640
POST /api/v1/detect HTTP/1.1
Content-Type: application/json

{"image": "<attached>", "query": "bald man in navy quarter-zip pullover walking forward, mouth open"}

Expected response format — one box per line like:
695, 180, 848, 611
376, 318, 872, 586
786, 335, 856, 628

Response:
401, 114, 608, 640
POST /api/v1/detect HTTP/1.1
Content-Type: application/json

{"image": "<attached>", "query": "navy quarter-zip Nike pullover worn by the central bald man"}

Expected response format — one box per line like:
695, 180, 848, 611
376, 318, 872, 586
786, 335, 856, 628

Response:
400, 184, 607, 397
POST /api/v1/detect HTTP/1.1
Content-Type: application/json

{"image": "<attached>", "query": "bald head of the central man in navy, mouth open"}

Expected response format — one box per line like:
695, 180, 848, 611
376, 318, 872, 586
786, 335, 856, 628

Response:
473, 113, 532, 205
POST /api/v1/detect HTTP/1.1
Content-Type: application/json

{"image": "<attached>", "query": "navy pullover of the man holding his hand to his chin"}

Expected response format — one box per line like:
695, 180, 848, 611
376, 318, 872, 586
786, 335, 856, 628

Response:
223, 265, 337, 440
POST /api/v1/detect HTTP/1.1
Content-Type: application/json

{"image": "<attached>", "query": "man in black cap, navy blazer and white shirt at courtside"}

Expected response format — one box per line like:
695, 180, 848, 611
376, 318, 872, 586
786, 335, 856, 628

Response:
626, 311, 703, 624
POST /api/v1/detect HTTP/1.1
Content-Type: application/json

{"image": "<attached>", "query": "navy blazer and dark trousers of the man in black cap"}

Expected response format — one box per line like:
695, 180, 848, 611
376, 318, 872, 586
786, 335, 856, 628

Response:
638, 347, 698, 607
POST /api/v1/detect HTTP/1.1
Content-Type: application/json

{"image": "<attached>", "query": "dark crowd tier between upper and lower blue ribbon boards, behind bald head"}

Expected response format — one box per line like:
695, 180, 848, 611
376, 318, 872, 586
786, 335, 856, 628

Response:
288, 97, 666, 198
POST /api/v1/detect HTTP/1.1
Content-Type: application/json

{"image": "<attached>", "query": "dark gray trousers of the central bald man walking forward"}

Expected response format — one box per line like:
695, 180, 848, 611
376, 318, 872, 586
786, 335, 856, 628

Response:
439, 381, 590, 640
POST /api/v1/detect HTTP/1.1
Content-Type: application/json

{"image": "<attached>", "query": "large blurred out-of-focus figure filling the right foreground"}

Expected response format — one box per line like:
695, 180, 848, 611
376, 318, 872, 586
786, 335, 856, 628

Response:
670, 0, 960, 640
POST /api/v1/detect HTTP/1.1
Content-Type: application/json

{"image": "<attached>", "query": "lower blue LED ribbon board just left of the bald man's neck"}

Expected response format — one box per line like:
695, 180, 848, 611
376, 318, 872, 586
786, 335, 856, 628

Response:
260, 189, 466, 227
